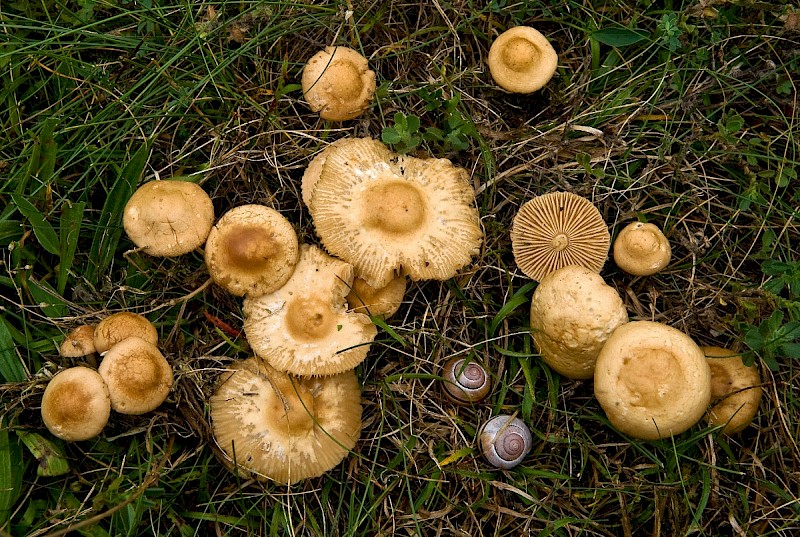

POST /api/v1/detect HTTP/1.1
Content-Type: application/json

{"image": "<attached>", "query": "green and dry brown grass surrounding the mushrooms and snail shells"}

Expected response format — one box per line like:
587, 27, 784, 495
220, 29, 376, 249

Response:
0, 0, 800, 537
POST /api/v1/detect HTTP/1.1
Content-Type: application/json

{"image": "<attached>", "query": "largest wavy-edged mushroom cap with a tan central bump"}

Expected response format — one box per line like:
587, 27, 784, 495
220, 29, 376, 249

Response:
311, 138, 483, 288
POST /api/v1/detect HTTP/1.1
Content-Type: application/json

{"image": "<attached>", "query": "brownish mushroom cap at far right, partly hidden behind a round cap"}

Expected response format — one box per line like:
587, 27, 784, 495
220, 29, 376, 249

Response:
702, 347, 762, 435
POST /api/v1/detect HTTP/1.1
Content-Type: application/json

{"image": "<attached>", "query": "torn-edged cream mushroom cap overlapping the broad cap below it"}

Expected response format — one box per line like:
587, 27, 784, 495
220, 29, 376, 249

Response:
244, 244, 377, 375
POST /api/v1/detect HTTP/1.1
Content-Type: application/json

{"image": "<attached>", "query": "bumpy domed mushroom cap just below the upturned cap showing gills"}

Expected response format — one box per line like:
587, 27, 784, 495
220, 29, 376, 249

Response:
531, 265, 628, 379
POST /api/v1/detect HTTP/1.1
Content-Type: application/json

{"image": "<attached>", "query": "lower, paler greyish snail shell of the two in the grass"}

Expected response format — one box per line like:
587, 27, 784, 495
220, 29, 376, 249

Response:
478, 416, 533, 470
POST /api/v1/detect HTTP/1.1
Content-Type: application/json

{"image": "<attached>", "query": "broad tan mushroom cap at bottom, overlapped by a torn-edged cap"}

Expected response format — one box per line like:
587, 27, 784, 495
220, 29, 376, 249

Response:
210, 358, 361, 484
